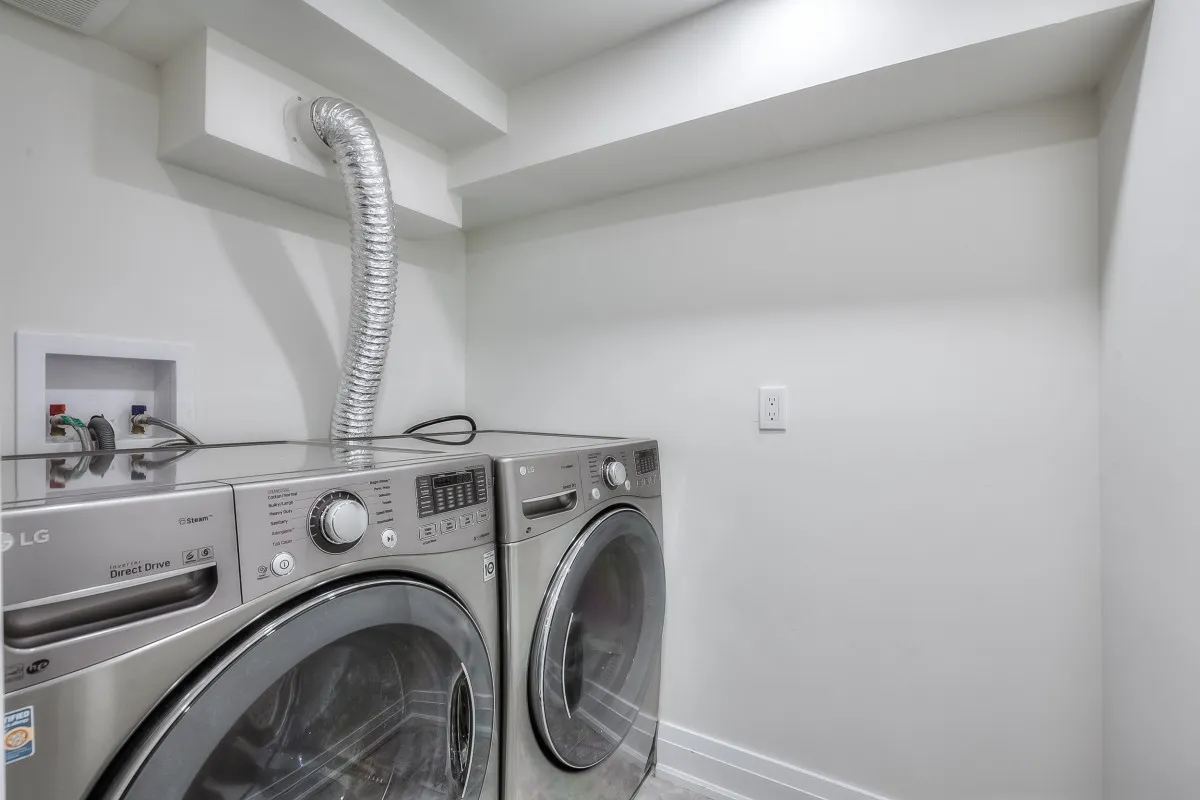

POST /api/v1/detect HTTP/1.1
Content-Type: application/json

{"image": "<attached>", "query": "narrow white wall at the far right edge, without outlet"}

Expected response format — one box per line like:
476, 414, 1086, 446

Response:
1100, 0, 1200, 800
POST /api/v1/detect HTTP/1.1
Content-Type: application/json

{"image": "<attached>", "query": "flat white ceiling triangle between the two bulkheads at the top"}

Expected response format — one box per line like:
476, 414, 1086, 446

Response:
386, 0, 721, 89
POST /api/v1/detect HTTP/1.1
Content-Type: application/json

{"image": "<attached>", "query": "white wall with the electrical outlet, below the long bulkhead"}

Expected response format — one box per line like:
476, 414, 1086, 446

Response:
467, 98, 1100, 800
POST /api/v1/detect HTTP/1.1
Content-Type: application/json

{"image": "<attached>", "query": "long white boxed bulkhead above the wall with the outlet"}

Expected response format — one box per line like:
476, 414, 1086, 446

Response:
450, 0, 1150, 228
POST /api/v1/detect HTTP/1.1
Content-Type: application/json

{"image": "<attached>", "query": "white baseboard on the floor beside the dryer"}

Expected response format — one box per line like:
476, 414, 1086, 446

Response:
659, 722, 888, 800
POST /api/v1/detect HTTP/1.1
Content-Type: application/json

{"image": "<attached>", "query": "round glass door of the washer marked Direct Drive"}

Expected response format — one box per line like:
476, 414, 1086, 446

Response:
100, 578, 494, 800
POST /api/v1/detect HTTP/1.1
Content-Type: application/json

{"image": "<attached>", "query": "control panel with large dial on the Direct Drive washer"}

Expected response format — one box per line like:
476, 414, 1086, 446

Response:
234, 455, 496, 601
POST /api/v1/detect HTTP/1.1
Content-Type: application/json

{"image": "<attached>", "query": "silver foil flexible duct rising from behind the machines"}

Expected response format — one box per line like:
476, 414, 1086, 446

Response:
312, 97, 396, 439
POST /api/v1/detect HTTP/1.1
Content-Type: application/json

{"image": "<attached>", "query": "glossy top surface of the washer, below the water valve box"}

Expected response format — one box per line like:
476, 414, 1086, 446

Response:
0, 441, 451, 507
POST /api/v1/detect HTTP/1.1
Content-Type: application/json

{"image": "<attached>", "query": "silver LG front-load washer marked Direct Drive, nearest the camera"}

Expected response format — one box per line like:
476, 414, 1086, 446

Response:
2, 443, 500, 800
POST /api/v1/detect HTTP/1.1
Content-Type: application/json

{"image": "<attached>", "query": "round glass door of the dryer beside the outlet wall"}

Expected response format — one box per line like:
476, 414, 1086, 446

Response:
529, 509, 666, 769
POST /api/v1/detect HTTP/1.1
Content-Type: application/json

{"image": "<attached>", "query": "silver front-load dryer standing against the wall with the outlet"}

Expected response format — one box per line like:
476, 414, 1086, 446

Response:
340, 431, 666, 800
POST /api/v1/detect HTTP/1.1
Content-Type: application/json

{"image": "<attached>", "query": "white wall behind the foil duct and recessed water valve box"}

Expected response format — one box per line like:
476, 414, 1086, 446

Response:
0, 5, 464, 445
